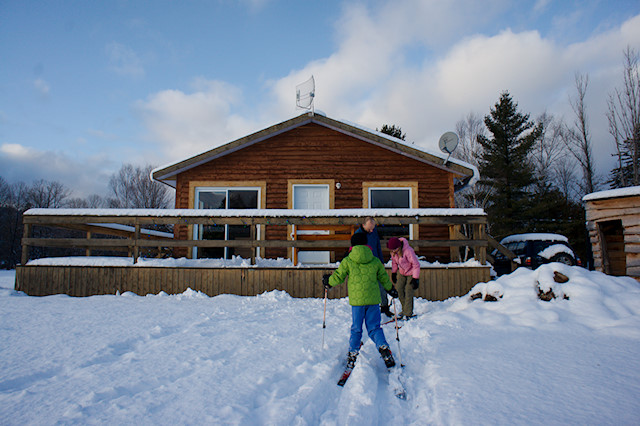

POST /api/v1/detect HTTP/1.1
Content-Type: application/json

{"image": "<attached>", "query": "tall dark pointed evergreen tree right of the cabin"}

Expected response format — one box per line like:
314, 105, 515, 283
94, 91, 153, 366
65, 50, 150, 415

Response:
478, 92, 542, 237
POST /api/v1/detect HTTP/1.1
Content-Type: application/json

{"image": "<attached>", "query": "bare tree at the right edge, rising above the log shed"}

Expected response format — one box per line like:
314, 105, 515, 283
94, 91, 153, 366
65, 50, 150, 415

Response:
607, 47, 640, 187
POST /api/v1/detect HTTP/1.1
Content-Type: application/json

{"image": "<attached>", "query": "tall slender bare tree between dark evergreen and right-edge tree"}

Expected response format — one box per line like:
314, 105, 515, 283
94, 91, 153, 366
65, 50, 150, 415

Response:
562, 73, 596, 194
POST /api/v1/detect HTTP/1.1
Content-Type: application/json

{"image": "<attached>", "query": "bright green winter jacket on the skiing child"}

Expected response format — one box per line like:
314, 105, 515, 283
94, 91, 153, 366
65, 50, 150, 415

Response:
329, 246, 392, 306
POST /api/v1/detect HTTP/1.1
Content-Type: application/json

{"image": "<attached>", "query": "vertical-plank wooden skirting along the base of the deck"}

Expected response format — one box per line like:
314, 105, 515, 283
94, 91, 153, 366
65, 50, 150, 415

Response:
15, 266, 490, 300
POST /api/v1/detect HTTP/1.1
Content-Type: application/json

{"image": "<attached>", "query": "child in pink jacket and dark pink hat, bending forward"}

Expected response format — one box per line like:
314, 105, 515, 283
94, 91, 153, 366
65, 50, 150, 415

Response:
387, 237, 420, 319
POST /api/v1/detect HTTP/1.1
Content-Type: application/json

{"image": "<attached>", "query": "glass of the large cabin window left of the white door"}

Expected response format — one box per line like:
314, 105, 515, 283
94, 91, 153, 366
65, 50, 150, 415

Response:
193, 187, 260, 259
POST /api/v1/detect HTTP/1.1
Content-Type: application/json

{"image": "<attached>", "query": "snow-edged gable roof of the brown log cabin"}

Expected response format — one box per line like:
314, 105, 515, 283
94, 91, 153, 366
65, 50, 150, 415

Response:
151, 111, 479, 188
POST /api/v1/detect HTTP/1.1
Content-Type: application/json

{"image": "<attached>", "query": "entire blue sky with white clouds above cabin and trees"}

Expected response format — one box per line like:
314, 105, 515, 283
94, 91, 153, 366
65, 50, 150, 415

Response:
0, 0, 640, 197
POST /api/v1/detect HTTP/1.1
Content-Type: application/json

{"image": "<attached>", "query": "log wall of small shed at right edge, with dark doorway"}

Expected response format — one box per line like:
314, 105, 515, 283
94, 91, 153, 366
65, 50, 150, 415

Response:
585, 195, 640, 281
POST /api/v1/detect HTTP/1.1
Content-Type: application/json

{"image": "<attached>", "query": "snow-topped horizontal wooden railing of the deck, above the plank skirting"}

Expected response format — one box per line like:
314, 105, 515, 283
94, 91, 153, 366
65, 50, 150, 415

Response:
22, 209, 488, 265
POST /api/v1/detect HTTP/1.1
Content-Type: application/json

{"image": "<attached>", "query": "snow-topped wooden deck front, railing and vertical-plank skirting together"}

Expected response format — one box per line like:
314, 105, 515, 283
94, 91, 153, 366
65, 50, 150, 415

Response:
16, 209, 490, 300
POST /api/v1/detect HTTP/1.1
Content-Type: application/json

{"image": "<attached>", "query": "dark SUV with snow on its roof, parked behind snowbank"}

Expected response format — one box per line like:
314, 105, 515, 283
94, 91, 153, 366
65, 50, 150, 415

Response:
491, 234, 582, 275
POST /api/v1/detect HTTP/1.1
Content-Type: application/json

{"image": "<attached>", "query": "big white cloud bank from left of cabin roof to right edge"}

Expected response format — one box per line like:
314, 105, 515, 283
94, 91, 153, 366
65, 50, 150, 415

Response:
137, 0, 640, 181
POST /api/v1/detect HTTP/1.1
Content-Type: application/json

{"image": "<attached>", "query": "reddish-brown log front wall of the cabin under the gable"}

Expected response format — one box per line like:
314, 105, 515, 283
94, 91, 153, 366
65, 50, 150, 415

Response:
176, 123, 455, 262
